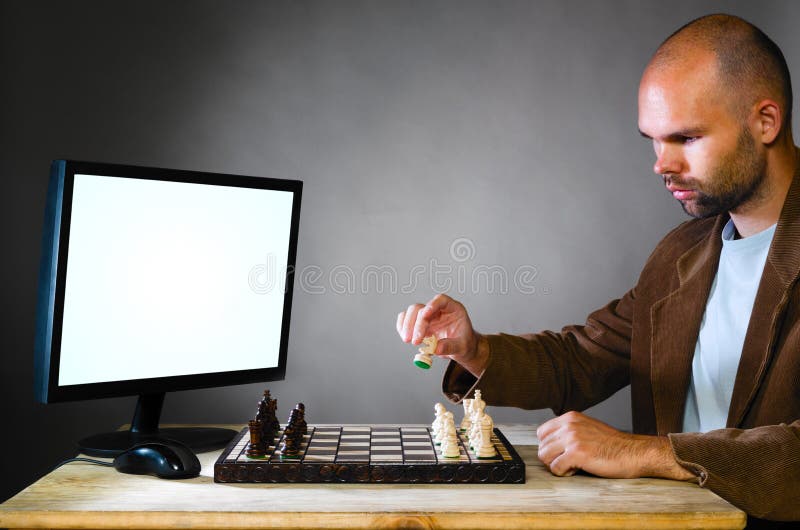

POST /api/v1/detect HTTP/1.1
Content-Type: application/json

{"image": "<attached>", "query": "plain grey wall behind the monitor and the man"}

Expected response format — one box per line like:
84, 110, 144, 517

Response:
0, 0, 800, 500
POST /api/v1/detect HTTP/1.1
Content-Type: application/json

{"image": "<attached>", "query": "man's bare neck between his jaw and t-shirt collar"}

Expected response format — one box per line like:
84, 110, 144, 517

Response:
730, 146, 800, 238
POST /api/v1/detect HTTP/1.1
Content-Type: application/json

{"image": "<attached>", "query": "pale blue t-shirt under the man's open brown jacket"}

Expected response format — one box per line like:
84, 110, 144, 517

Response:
683, 220, 776, 432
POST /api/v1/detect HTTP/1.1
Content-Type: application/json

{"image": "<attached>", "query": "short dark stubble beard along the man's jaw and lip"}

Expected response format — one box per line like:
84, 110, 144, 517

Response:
663, 128, 766, 219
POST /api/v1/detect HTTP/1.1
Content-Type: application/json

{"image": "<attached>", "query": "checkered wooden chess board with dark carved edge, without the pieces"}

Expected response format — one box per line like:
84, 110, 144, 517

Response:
214, 425, 525, 484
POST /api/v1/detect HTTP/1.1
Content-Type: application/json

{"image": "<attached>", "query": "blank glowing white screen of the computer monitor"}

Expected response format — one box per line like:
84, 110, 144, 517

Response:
58, 175, 292, 385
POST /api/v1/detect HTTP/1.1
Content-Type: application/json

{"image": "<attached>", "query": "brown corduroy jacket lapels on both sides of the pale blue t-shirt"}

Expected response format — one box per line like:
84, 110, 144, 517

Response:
650, 152, 800, 435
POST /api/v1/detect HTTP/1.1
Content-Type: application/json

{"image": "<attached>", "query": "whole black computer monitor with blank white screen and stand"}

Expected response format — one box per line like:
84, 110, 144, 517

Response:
35, 160, 302, 456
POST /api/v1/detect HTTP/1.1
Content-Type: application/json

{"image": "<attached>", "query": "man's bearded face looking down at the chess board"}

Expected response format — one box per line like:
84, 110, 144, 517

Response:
639, 57, 766, 218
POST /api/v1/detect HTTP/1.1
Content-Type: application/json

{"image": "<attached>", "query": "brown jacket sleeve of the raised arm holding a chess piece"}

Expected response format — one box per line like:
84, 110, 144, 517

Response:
442, 290, 635, 414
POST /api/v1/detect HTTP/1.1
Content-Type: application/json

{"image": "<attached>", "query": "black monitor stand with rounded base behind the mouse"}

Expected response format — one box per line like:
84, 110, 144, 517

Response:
78, 392, 236, 457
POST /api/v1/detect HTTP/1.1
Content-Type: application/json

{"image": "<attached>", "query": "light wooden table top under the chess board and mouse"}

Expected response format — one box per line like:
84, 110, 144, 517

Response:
0, 425, 746, 530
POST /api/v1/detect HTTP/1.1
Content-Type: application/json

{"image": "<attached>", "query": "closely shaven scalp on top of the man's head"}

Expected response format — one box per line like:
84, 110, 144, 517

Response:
645, 15, 792, 134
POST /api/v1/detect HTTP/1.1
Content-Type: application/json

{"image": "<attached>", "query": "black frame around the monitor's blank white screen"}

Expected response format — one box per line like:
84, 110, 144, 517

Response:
36, 160, 303, 403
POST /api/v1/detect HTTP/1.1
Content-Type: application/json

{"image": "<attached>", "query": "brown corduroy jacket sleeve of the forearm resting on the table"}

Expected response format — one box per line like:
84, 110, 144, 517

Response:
669, 420, 800, 521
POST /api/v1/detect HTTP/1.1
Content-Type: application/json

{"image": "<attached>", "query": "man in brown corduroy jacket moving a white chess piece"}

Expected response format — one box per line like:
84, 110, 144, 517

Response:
397, 15, 800, 523
